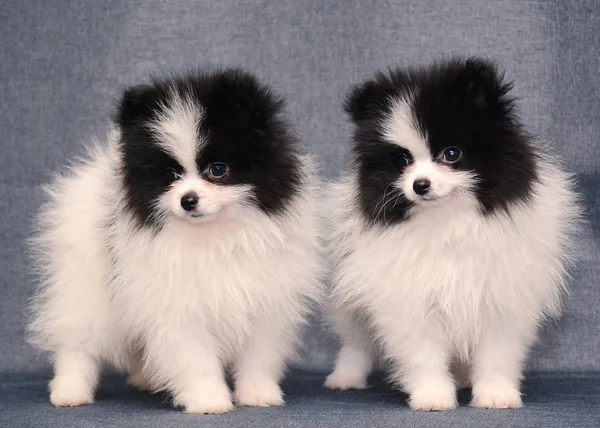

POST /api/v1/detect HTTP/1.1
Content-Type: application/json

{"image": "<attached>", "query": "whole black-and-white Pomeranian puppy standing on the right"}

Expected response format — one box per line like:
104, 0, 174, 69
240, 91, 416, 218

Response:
325, 58, 580, 410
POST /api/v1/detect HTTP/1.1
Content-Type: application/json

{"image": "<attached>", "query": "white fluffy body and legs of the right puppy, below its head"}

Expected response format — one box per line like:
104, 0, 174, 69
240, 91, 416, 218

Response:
326, 149, 581, 410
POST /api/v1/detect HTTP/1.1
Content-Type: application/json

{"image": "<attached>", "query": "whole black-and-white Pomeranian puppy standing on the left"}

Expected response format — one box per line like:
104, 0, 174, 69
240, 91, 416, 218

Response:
30, 69, 321, 413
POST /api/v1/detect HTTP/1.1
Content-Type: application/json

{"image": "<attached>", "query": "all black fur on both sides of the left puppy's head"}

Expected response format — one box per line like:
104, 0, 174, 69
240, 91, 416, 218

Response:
115, 69, 302, 231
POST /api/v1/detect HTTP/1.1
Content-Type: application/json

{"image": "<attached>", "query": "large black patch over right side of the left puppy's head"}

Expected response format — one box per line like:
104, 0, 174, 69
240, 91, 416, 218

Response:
197, 70, 301, 214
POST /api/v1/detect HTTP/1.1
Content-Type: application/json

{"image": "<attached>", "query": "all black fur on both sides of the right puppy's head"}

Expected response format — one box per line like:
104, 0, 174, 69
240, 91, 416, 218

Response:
346, 58, 537, 223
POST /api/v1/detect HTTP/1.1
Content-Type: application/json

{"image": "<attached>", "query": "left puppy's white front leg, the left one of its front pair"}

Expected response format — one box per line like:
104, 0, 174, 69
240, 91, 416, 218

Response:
145, 322, 233, 414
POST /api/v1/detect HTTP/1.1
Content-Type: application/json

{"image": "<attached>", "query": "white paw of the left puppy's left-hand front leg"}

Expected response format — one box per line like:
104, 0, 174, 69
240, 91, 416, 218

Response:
173, 383, 233, 415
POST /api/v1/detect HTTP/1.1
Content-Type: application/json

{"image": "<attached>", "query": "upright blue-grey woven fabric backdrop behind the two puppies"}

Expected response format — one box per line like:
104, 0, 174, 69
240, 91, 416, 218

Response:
0, 0, 600, 424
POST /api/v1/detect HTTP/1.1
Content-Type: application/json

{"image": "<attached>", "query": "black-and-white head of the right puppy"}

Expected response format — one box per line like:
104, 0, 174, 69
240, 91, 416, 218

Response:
346, 58, 536, 223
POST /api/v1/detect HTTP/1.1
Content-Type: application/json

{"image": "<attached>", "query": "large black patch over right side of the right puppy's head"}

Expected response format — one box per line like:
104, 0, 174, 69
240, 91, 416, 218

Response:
415, 58, 537, 214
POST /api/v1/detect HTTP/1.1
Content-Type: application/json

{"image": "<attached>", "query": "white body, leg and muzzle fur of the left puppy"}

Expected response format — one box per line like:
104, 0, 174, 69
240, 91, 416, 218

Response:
29, 132, 321, 413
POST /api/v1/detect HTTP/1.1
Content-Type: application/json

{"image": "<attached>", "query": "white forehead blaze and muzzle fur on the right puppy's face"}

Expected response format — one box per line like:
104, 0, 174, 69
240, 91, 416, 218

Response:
383, 99, 476, 205
